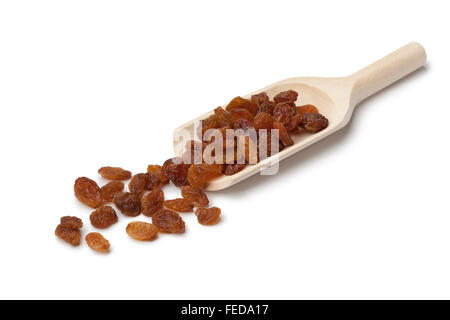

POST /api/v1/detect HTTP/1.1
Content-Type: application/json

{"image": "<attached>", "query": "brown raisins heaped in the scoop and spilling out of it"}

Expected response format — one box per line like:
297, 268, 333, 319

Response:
55, 90, 328, 253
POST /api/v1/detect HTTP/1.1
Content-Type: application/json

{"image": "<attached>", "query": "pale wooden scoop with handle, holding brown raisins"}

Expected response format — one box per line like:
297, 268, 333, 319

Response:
174, 42, 426, 191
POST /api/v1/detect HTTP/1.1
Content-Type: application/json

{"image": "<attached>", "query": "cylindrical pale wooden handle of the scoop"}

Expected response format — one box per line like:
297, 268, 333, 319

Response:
350, 42, 427, 105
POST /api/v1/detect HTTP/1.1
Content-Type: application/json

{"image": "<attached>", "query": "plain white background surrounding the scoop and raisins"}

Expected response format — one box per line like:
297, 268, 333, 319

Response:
0, 0, 450, 299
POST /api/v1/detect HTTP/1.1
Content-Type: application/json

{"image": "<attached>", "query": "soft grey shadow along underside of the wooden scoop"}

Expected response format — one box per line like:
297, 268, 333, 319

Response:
217, 64, 430, 198
